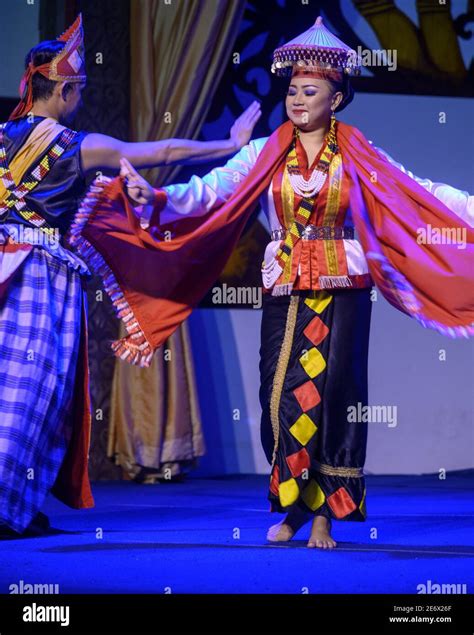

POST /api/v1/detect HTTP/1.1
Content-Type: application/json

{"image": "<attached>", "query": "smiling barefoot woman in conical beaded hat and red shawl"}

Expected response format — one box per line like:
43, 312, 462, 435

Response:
77, 18, 474, 548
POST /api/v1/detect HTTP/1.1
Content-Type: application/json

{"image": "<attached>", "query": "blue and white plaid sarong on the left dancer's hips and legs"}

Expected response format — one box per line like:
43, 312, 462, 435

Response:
0, 247, 85, 532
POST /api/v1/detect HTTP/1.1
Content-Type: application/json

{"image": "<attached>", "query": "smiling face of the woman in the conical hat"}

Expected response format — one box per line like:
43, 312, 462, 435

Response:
286, 77, 343, 132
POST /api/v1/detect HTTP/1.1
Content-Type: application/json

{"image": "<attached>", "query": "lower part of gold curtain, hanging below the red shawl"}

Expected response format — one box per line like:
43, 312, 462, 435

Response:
108, 324, 205, 480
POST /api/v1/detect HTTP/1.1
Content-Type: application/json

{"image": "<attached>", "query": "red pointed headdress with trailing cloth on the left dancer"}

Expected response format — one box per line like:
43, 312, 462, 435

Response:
9, 14, 86, 120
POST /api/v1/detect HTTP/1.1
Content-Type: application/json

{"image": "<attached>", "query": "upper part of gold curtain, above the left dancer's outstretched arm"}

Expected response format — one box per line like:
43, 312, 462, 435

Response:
131, 0, 246, 185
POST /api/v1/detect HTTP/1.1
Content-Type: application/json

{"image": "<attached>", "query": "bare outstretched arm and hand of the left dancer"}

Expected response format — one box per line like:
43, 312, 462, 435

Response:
81, 101, 261, 172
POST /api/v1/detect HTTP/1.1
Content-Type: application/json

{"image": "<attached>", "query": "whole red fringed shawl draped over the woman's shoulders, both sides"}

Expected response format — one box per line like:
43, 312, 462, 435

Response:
70, 121, 474, 366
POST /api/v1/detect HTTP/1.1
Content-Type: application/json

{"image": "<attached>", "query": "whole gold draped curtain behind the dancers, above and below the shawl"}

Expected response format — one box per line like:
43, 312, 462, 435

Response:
108, 0, 245, 481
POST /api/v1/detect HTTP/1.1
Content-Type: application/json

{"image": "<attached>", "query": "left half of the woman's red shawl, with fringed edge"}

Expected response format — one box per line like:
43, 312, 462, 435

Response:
69, 123, 293, 366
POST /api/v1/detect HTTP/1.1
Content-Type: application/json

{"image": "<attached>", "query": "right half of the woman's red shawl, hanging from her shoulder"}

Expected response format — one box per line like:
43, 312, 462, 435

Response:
337, 123, 474, 337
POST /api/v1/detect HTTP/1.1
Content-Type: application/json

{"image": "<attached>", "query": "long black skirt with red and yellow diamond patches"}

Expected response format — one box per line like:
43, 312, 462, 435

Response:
260, 289, 372, 520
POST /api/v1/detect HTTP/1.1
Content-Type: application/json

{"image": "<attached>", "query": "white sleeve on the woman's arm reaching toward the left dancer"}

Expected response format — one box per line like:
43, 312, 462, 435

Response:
156, 138, 267, 224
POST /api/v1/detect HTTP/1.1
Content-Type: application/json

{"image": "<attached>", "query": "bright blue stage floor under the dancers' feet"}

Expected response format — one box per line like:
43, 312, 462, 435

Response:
0, 472, 474, 593
